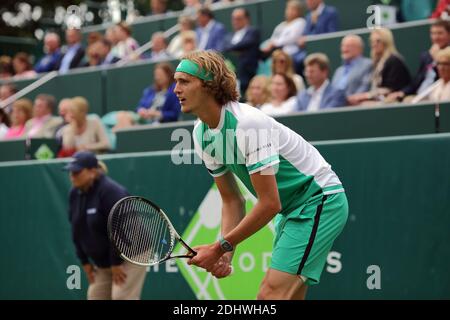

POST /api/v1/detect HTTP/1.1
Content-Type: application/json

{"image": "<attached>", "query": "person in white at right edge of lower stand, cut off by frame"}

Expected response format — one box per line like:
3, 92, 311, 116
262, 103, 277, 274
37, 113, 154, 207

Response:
425, 46, 450, 101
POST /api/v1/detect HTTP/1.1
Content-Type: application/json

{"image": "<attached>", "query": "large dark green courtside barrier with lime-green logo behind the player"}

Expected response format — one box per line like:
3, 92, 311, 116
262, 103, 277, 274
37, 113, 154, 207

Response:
0, 134, 450, 299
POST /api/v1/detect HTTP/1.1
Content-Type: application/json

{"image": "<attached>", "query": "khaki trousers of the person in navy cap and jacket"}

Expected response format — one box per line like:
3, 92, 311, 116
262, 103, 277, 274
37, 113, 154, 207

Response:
87, 261, 147, 300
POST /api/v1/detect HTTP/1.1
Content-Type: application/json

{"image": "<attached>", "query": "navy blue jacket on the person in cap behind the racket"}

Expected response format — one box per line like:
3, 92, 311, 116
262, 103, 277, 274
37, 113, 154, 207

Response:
69, 175, 129, 268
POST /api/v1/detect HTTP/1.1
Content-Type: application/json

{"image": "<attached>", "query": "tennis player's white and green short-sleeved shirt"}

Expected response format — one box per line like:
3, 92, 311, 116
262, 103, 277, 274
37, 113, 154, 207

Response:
193, 102, 344, 214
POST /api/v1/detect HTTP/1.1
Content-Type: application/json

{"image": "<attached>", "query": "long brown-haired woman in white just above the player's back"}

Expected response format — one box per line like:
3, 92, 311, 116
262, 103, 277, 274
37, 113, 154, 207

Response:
261, 73, 297, 116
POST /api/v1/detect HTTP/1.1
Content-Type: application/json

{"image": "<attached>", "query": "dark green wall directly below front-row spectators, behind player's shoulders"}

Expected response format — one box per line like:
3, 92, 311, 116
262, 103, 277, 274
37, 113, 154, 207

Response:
116, 103, 450, 152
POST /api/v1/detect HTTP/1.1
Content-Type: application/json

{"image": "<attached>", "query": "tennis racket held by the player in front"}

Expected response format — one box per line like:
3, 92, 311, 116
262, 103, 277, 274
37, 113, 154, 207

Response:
108, 196, 197, 266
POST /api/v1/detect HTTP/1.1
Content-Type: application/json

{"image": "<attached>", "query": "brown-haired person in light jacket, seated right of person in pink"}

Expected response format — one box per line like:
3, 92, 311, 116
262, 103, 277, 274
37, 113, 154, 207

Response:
25, 94, 62, 138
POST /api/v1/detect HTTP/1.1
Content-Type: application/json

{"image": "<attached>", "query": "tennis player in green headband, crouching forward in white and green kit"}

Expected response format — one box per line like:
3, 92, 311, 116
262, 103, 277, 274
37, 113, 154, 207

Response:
174, 51, 348, 299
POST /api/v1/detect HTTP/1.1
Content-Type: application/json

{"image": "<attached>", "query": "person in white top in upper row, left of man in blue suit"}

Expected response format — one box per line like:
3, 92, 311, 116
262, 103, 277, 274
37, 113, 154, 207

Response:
261, 0, 306, 57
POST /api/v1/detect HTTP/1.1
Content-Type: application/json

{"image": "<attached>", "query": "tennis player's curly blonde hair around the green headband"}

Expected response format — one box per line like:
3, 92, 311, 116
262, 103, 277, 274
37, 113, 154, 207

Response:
183, 50, 239, 105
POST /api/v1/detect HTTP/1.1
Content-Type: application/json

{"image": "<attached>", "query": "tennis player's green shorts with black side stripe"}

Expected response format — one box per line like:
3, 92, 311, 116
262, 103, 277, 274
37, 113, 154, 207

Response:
270, 192, 348, 285
